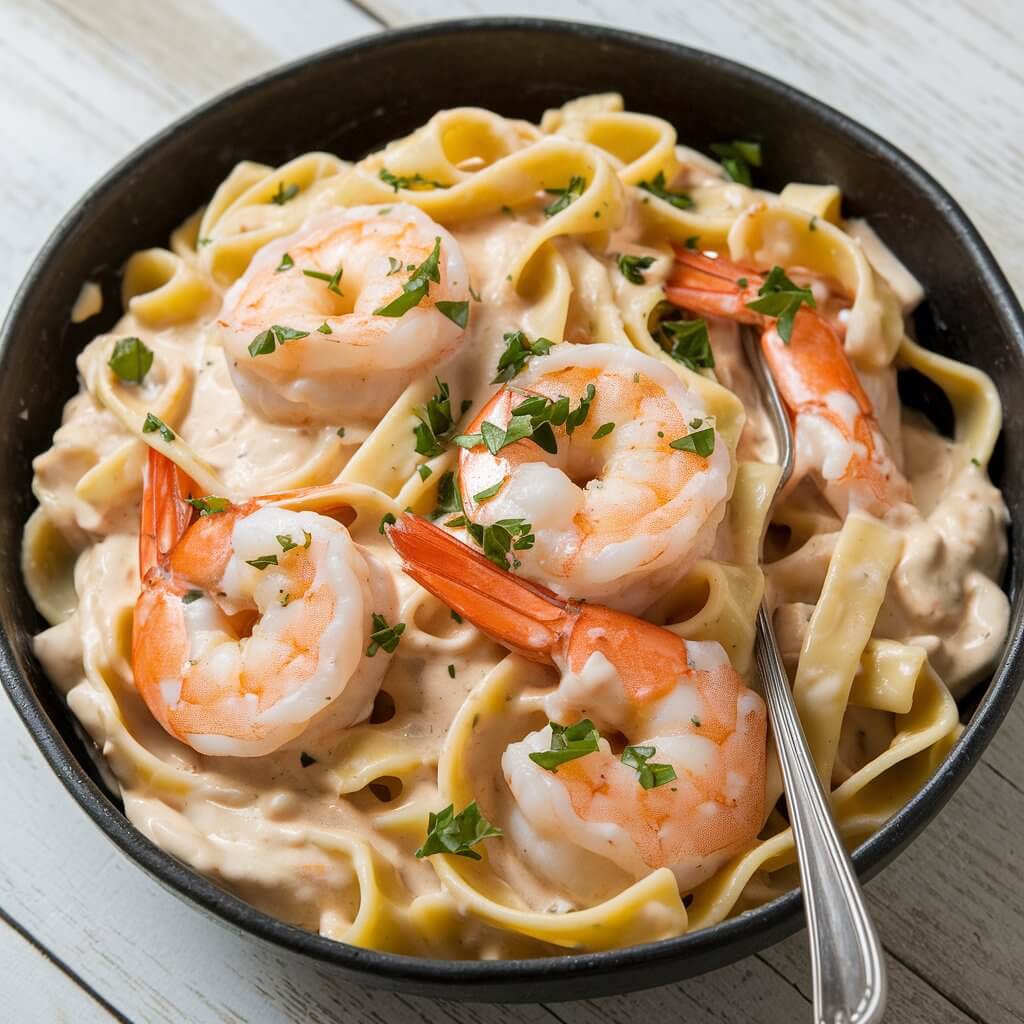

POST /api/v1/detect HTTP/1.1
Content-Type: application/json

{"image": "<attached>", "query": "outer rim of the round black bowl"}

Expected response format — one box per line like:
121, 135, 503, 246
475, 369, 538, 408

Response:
0, 16, 1024, 998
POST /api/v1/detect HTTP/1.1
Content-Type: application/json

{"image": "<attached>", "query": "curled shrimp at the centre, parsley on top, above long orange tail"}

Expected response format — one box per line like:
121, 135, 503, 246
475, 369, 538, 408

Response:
459, 344, 731, 610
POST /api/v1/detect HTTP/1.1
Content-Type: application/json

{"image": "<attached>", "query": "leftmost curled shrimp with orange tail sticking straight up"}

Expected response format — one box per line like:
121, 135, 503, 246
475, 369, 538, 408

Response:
132, 452, 395, 757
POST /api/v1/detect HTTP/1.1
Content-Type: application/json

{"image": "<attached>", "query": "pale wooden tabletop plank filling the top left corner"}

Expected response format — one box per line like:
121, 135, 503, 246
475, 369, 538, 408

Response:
0, 0, 378, 310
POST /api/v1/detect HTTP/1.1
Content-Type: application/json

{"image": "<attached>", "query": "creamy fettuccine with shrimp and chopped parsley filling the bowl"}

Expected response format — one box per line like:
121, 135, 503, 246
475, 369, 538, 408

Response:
24, 95, 1009, 958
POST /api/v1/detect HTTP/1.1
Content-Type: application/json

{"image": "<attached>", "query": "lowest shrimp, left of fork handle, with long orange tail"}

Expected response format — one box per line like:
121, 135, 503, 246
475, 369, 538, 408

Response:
389, 515, 766, 891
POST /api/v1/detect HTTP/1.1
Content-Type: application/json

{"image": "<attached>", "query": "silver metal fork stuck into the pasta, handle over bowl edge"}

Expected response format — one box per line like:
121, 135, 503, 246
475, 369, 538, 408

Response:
742, 328, 886, 1024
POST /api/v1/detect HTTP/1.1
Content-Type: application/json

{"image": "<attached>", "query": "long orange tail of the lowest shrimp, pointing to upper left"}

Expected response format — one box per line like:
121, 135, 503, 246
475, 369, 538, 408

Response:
387, 513, 577, 663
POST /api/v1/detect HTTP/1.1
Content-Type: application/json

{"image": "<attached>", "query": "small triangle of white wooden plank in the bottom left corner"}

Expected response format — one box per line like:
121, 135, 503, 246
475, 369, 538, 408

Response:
0, 919, 116, 1024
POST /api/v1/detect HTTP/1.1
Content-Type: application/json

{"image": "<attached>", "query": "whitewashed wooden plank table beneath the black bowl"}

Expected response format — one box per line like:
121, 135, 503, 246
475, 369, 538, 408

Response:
0, 0, 1024, 1024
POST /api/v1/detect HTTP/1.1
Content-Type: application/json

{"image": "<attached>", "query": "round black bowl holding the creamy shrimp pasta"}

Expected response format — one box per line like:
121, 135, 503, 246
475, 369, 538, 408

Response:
0, 18, 1024, 1000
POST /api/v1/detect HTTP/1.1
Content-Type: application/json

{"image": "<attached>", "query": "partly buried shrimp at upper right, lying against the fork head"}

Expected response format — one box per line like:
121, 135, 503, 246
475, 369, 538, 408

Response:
665, 247, 910, 515
